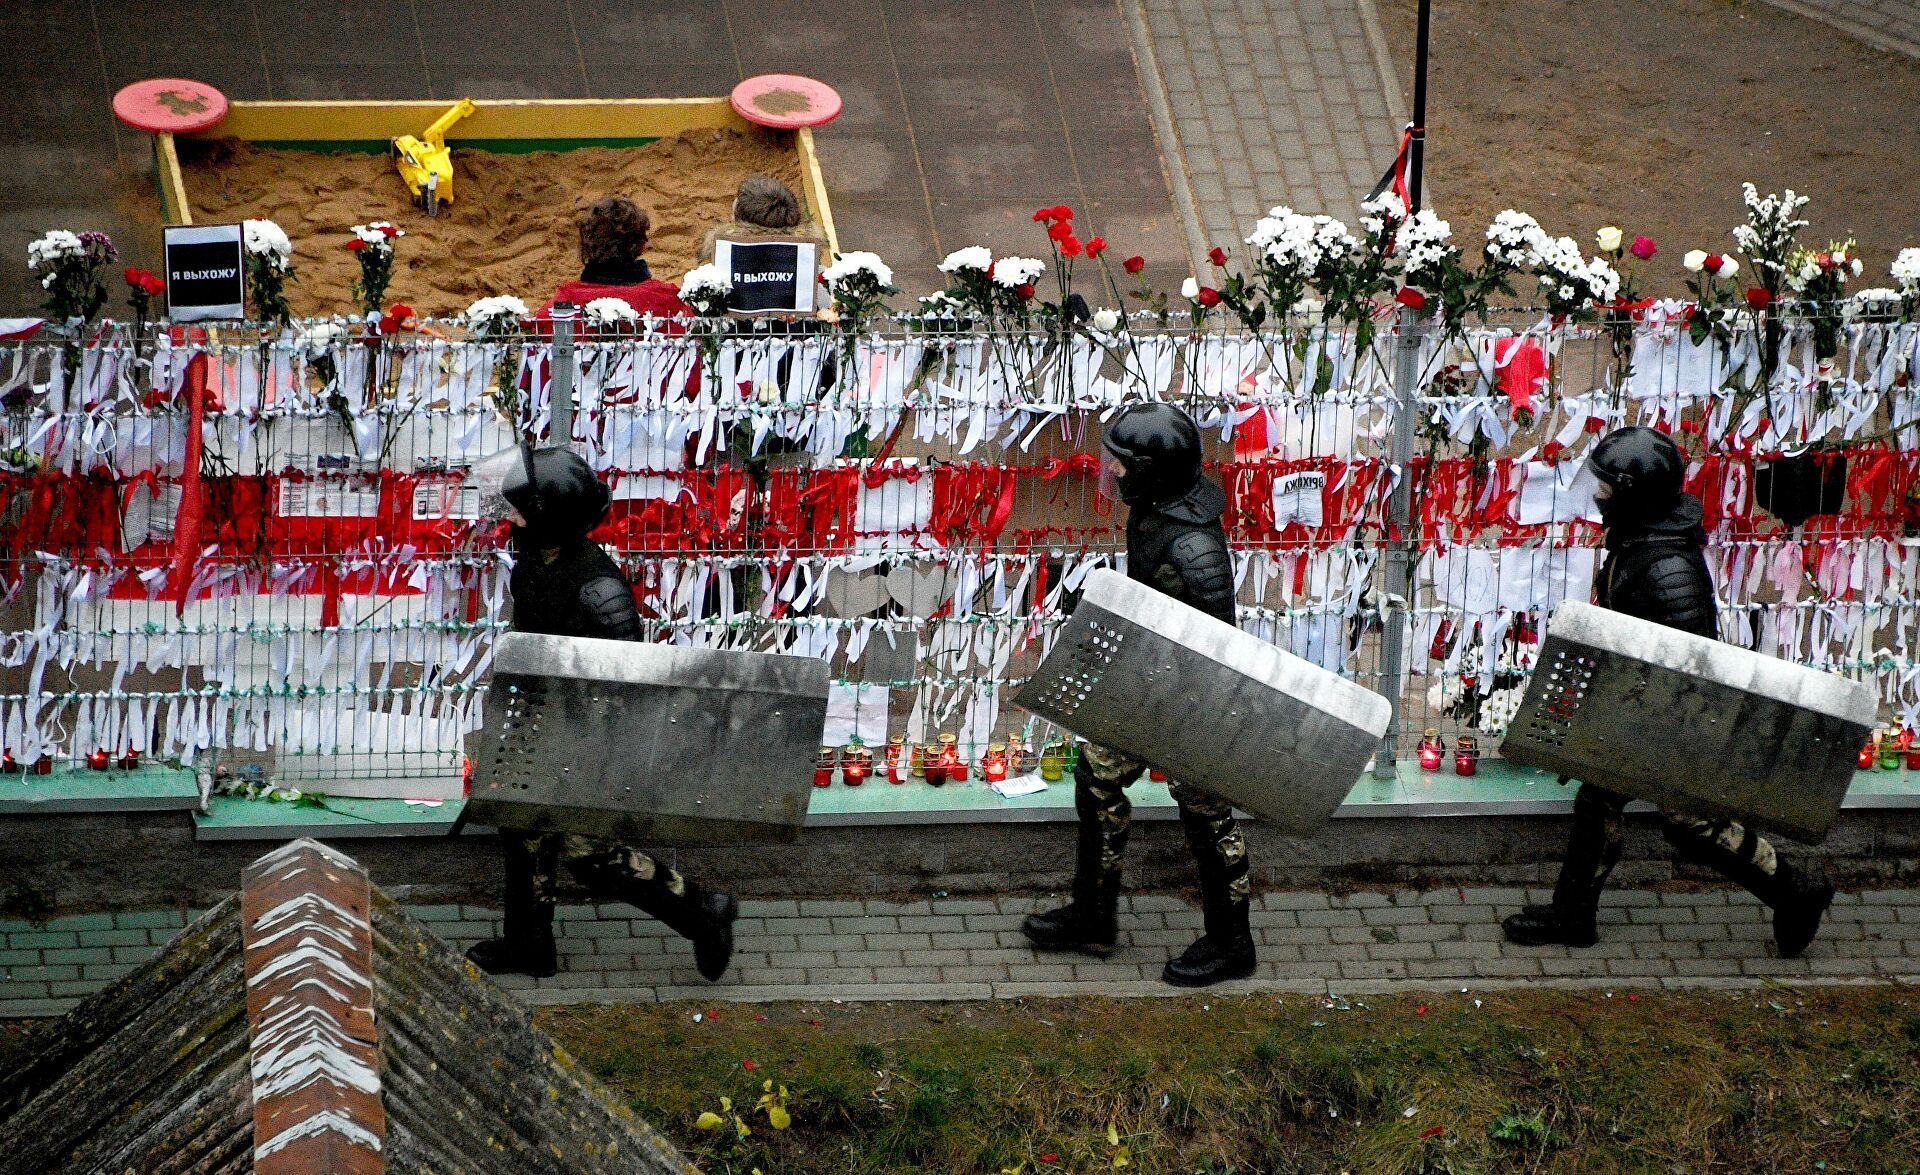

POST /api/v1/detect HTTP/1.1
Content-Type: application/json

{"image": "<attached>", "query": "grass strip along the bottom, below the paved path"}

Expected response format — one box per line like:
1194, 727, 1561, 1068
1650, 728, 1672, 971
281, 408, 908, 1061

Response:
538, 987, 1920, 1175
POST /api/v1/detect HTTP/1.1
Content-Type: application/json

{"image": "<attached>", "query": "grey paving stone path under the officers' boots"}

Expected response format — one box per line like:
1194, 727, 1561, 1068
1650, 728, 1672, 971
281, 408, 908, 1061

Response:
0, 889, 1920, 1016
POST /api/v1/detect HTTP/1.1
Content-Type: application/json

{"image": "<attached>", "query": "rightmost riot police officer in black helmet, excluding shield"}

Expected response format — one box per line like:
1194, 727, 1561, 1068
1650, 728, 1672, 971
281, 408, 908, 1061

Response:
1501, 428, 1834, 958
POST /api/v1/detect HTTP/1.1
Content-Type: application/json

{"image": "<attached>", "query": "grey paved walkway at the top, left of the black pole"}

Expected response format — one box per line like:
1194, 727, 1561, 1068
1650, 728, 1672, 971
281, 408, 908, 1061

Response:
1121, 0, 1405, 273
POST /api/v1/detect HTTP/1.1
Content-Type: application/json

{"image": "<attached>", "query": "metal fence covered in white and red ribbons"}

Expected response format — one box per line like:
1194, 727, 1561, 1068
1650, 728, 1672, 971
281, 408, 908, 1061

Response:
0, 305, 1920, 795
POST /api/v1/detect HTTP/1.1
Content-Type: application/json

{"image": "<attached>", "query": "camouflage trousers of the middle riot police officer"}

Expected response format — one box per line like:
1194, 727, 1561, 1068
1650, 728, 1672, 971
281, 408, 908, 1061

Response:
1073, 743, 1252, 933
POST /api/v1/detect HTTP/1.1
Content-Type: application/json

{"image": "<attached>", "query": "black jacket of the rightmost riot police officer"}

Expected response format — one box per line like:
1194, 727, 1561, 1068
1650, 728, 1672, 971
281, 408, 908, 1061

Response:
1594, 493, 1720, 637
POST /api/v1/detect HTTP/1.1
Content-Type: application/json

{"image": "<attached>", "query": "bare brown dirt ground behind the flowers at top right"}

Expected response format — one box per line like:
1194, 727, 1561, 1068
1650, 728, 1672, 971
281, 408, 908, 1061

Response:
1379, 0, 1920, 294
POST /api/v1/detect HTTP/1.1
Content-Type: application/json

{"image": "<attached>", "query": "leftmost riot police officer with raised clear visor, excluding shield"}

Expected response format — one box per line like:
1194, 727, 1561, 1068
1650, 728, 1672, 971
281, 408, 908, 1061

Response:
467, 445, 739, 979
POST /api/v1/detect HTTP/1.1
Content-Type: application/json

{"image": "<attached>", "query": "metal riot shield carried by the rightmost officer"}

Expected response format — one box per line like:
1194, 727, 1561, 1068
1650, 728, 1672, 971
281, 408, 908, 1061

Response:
1500, 601, 1876, 841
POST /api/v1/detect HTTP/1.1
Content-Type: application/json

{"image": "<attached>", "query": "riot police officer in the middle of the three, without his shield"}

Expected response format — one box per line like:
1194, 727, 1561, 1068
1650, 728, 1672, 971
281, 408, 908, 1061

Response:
1021, 403, 1256, 987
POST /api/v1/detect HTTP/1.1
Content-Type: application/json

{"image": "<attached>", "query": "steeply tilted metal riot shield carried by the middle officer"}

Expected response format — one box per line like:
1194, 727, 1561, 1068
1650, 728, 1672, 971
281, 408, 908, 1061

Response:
1014, 570, 1392, 833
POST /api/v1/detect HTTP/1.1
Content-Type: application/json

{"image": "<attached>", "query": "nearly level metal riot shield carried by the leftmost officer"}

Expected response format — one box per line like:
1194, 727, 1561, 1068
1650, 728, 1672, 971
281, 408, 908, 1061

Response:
467, 632, 828, 843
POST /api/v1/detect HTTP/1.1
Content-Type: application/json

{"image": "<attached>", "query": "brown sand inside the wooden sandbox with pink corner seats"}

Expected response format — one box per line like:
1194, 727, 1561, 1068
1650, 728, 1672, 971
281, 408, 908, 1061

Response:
180, 131, 801, 315
